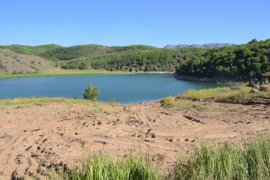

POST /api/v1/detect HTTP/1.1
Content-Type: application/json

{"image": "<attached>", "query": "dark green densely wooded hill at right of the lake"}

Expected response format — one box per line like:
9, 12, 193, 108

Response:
176, 39, 270, 80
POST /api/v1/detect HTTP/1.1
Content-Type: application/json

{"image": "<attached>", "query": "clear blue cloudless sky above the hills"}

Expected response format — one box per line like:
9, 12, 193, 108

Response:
0, 0, 270, 47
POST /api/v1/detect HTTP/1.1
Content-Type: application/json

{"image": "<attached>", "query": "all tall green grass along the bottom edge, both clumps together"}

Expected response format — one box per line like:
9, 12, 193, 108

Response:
49, 136, 270, 180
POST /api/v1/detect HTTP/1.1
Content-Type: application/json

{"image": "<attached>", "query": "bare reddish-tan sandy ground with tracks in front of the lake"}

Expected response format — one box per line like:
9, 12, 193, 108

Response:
0, 102, 270, 179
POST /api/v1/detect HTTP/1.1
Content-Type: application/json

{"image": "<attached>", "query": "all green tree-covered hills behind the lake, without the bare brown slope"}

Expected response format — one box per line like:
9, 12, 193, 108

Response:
0, 39, 270, 80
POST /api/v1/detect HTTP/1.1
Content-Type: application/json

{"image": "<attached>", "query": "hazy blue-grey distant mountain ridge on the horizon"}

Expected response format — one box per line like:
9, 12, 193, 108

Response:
164, 43, 237, 49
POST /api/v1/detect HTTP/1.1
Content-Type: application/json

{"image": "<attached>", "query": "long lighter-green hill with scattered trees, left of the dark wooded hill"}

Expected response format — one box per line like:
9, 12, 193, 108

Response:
0, 45, 205, 72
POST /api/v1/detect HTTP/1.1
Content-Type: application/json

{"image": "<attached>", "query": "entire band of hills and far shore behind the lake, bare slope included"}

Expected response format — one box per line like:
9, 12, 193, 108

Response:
0, 40, 270, 82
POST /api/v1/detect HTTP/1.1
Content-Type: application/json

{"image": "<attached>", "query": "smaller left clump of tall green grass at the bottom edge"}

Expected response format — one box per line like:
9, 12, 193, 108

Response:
63, 155, 160, 180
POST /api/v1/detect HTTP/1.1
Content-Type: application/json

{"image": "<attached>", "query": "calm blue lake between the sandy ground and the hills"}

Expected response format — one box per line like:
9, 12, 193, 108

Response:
0, 74, 216, 104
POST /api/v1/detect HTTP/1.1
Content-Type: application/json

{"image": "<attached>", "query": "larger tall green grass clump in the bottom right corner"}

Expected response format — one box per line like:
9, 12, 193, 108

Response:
173, 137, 270, 180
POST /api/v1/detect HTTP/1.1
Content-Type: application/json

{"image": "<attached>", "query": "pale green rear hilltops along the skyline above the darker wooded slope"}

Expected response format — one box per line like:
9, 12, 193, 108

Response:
0, 44, 158, 60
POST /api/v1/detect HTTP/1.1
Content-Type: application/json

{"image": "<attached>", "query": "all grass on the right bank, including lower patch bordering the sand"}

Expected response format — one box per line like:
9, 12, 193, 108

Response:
161, 85, 270, 111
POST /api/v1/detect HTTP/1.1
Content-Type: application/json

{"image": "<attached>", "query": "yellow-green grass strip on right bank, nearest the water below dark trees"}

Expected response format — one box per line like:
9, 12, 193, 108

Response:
181, 85, 270, 101
